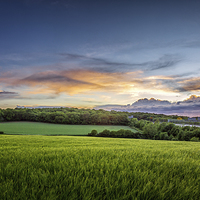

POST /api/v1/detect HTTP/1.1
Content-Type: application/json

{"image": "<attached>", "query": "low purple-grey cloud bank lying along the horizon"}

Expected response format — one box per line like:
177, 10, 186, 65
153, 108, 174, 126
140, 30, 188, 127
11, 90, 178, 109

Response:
1, 95, 200, 117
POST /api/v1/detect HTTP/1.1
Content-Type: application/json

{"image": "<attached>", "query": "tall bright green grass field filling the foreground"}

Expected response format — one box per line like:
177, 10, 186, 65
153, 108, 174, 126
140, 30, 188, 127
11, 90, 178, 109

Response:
0, 135, 200, 200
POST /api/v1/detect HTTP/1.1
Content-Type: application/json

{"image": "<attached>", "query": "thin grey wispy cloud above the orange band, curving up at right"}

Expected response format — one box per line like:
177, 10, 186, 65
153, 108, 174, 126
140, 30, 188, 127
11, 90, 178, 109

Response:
59, 53, 182, 73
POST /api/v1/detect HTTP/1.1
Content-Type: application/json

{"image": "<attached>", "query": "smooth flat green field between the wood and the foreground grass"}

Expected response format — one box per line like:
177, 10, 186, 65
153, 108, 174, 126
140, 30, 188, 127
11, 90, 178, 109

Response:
0, 122, 136, 135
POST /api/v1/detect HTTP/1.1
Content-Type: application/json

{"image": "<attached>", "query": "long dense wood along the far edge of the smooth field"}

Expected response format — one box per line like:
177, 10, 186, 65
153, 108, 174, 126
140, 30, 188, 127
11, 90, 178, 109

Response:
0, 108, 129, 125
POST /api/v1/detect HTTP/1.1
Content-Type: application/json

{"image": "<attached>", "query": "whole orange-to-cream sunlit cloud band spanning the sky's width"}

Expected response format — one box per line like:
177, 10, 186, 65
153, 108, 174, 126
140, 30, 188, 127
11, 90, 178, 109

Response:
0, 66, 195, 98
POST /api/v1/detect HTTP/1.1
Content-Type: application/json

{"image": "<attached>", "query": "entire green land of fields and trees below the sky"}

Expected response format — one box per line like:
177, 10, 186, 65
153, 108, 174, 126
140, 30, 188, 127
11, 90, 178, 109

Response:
0, 108, 200, 200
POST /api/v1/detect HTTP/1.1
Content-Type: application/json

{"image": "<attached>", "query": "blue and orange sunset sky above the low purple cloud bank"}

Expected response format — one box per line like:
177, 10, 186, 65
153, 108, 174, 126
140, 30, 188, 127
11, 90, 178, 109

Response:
0, 0, 200, 114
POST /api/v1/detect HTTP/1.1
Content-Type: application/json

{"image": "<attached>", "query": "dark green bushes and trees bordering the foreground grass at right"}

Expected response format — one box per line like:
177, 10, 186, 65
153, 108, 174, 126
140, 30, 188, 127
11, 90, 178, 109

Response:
88, 118, 200, 141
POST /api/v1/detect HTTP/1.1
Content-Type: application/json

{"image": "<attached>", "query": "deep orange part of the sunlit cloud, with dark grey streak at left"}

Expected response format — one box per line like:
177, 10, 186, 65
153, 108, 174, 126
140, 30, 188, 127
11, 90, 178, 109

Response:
13, 70, 146, 95
